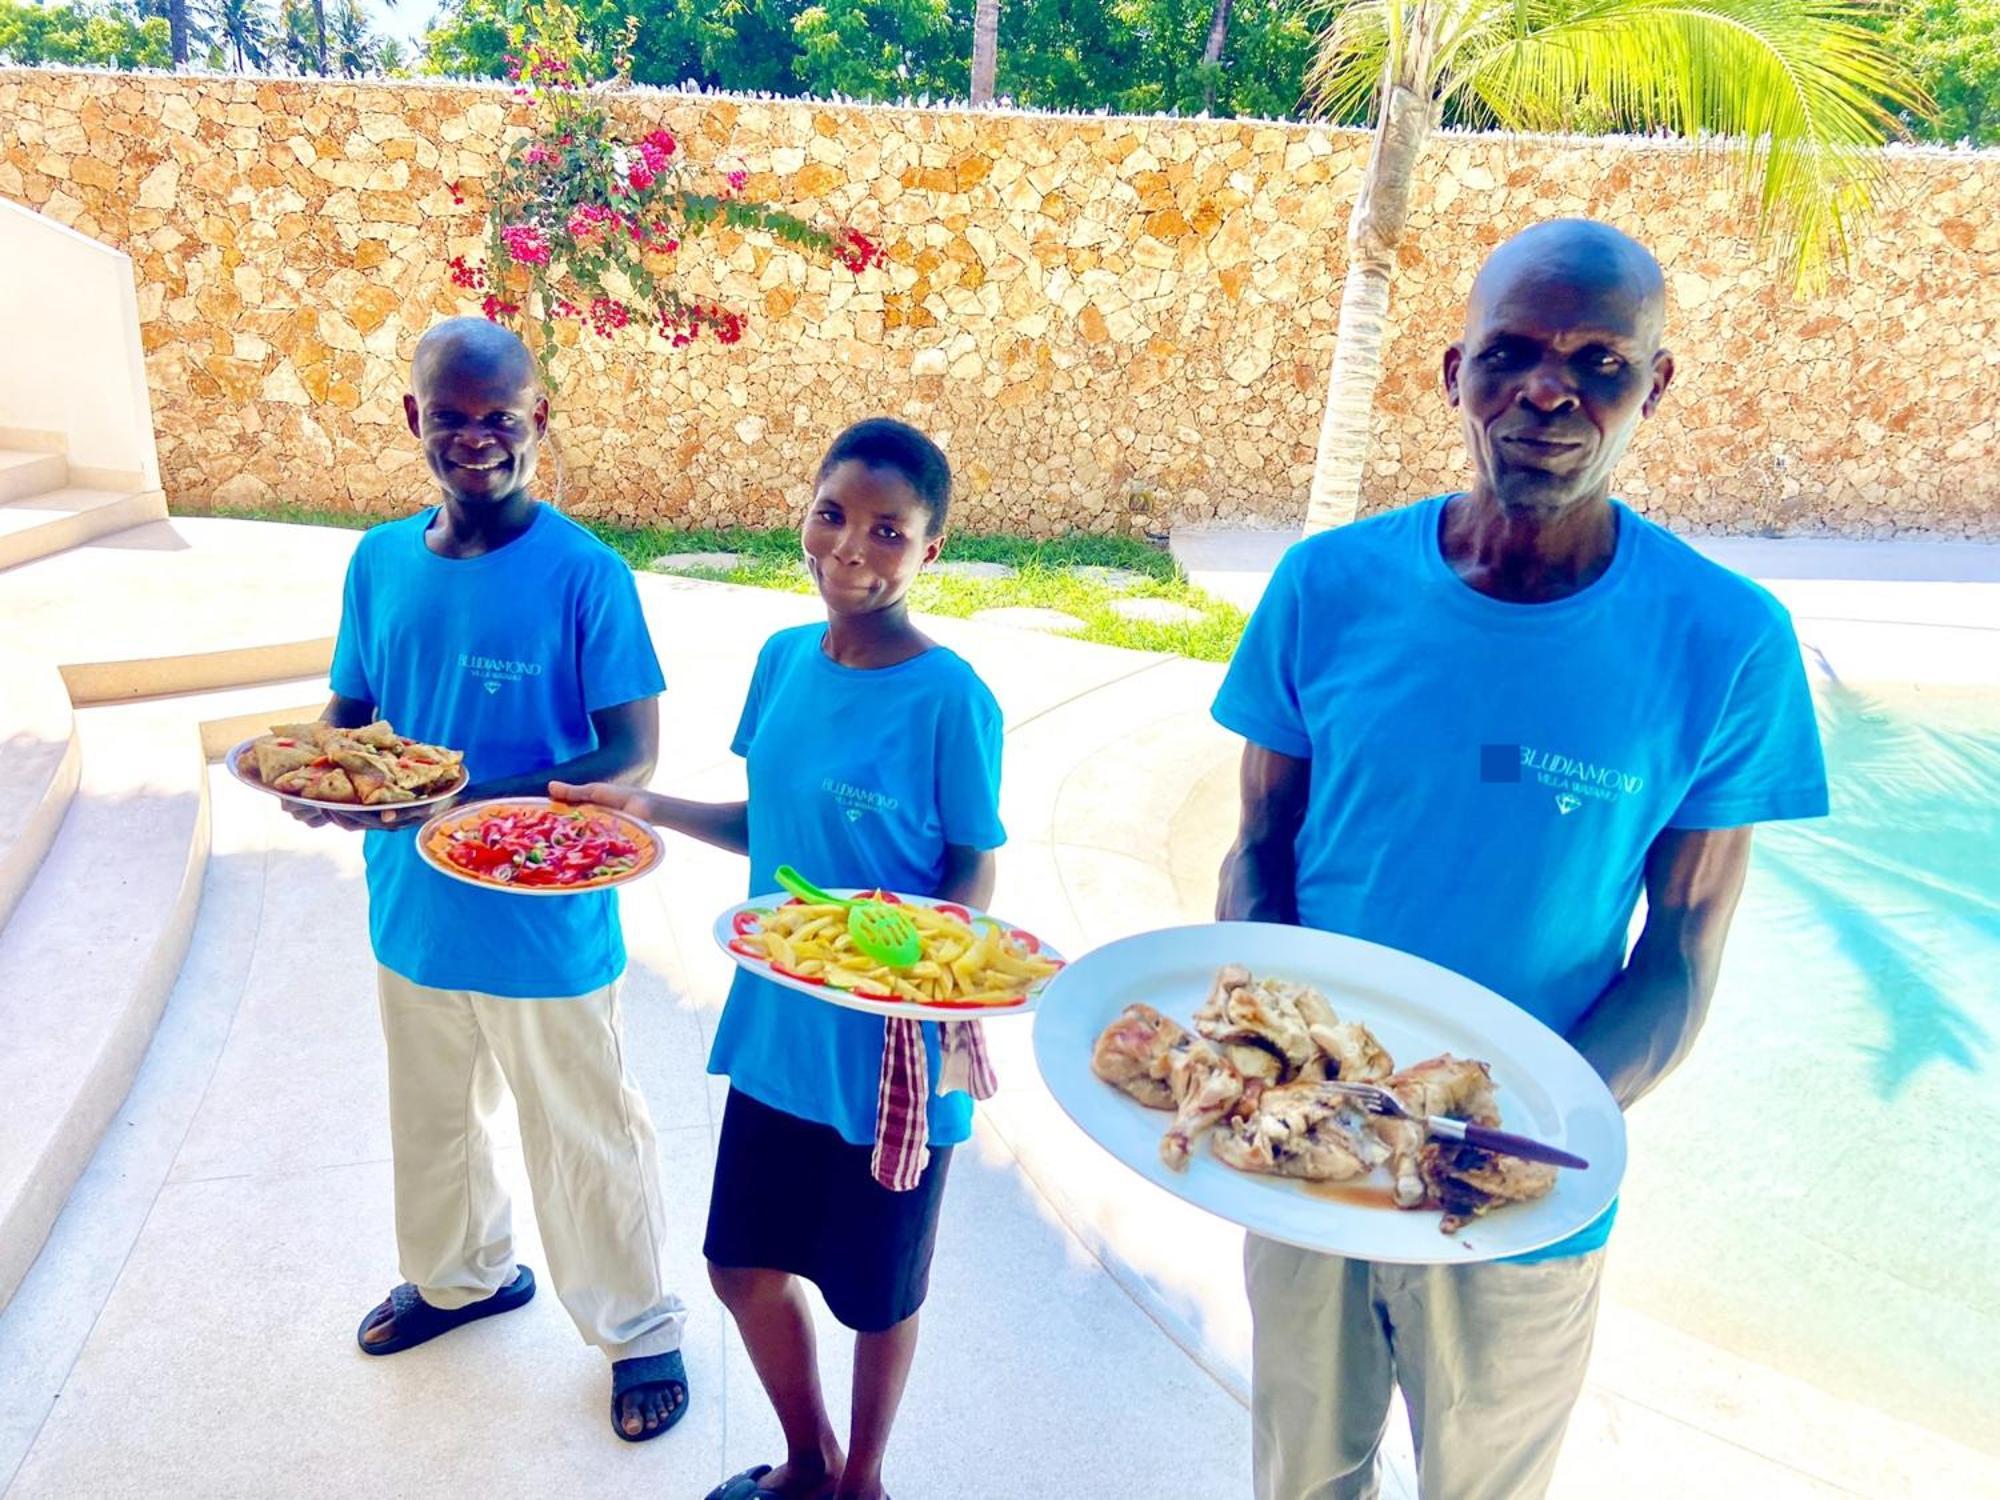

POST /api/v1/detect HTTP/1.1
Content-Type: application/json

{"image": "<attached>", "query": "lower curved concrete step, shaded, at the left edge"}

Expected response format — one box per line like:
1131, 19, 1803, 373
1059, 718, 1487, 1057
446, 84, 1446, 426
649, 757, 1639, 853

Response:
0, 702, 208, 1304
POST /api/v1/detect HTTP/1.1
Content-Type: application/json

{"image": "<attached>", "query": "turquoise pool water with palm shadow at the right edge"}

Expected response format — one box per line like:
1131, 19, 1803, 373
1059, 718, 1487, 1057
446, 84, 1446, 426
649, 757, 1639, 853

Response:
1610, 686, 2000, 1452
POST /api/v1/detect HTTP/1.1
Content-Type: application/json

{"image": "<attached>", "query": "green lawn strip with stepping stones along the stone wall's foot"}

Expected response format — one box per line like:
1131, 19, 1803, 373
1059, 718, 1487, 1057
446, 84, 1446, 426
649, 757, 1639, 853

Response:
186, 506, 1246, 662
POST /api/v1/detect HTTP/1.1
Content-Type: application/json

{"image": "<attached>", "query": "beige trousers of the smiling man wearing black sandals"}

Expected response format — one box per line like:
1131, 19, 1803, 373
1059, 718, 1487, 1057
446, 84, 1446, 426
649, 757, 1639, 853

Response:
378, 968, 688, 1360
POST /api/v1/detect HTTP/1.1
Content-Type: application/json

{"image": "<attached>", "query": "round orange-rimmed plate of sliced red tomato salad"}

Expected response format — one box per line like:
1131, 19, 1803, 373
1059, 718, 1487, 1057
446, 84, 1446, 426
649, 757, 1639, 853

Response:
416, 798, 666, 896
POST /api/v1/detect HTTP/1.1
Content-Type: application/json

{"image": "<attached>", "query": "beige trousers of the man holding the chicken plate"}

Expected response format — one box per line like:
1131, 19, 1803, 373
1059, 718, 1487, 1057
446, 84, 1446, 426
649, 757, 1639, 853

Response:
1244, 1234, 1604, 1500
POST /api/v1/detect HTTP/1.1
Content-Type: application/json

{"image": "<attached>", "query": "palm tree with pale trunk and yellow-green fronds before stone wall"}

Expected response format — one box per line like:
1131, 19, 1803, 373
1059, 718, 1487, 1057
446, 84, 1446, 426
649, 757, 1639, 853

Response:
1306, 0, 1926, 532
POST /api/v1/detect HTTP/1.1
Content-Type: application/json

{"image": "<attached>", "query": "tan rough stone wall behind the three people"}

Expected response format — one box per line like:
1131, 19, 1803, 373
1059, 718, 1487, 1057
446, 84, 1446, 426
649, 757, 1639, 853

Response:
0, 70, 2000, 536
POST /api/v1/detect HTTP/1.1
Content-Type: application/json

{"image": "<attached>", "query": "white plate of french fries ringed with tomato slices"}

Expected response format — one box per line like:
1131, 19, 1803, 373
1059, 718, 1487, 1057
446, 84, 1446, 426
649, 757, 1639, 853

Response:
716, 890, 1064, 1020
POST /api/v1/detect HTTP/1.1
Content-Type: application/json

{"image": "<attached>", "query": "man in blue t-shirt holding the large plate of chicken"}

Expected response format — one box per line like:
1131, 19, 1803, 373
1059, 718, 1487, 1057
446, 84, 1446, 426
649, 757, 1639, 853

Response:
1214, 220, 1826, 1500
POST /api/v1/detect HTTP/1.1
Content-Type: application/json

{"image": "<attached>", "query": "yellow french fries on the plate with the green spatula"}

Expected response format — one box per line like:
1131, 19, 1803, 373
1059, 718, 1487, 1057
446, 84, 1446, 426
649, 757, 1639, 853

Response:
744, 902, 1060, 1010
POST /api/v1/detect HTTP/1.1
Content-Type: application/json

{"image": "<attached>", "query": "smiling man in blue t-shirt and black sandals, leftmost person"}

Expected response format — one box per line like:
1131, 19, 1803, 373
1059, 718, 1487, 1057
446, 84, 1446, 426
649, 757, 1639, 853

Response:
306, 318, 688, 1442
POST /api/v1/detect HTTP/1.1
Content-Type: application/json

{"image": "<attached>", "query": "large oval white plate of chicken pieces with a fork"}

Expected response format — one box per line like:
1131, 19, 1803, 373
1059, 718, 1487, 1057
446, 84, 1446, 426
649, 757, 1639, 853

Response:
1034, 922, 1626, 1264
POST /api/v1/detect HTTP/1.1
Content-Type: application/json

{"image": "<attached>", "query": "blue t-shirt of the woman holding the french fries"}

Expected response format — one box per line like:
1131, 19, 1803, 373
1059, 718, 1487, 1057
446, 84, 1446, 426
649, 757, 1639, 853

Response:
708, 624, 1006, 1146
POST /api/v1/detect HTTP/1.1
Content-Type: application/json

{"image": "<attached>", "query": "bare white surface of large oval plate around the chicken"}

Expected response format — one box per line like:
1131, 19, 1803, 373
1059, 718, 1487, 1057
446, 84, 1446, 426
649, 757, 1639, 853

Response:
1034, 922, 1626, 1264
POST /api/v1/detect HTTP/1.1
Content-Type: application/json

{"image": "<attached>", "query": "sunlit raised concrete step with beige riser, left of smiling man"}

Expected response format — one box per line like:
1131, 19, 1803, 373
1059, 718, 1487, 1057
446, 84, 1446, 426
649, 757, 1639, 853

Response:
0, 520, 360, 704
